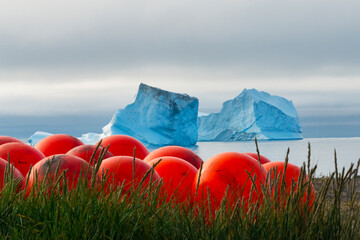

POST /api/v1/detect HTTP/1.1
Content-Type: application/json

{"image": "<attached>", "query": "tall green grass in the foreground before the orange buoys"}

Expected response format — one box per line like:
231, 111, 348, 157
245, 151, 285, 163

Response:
0, 143, 360, 239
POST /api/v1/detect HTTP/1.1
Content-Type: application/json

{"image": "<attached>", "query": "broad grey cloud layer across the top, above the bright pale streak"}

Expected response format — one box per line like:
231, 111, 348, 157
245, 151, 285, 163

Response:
0, 0, 360, 80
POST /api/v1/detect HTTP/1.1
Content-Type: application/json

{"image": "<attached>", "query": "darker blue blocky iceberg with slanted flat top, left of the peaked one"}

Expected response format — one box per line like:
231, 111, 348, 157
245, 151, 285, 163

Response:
103, 83, 199, 146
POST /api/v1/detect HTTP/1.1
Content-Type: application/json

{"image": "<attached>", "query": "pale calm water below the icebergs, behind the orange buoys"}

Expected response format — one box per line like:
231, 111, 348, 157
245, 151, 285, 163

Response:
192, 138, 360, 176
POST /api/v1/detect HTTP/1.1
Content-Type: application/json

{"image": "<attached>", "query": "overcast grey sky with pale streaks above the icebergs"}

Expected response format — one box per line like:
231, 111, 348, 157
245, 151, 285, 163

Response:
0, 0, 360, 137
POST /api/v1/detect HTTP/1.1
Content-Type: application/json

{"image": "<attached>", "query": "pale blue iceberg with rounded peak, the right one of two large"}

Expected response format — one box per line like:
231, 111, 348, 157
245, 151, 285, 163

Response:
198, 89, 302, 141
